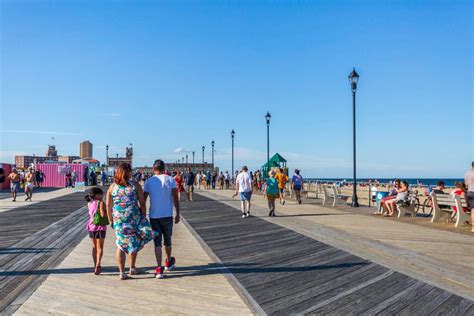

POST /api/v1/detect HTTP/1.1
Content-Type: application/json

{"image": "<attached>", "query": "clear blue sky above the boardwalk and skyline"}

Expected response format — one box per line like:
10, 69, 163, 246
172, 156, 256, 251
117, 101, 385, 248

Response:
0, 1, 474, 178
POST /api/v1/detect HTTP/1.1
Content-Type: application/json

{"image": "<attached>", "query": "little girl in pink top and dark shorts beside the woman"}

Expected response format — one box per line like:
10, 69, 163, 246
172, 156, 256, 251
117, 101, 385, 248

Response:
86, 187, 107, 275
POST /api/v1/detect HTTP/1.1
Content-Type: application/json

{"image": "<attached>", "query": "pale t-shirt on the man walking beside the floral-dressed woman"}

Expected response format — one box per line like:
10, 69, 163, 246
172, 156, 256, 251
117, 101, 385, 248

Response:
144, 174, 176, 218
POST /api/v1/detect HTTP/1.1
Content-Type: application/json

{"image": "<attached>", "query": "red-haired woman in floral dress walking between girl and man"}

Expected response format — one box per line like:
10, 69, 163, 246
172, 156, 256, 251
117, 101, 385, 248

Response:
107, 163, 153, 280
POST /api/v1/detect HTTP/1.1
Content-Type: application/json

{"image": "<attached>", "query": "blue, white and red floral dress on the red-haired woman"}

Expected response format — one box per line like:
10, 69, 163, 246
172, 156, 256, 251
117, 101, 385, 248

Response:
111, 184, 153, 254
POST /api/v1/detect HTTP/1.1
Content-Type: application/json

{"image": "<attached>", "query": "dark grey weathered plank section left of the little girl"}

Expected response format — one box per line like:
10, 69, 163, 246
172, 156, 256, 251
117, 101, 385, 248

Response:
0, 193, 87, 314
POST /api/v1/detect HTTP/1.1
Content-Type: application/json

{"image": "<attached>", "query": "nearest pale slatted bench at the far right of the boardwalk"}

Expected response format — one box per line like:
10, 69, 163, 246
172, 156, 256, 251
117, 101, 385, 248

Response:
431, 192, 472, 227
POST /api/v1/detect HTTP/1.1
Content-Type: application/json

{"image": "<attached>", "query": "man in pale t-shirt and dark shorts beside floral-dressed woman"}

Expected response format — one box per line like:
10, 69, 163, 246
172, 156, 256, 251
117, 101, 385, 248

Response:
144, 159, 180, 279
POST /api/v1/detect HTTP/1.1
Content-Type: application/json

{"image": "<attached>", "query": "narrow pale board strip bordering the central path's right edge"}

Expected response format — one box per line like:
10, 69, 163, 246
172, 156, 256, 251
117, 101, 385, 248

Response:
181, 216, 267, 315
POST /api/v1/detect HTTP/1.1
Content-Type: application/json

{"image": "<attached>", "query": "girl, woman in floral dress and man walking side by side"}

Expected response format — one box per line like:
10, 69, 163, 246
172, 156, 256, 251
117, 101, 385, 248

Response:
86, 160, 180, 280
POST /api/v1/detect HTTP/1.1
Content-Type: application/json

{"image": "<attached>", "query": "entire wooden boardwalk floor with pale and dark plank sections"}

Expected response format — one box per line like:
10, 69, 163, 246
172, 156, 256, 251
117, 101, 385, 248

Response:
0, 191, 474, 315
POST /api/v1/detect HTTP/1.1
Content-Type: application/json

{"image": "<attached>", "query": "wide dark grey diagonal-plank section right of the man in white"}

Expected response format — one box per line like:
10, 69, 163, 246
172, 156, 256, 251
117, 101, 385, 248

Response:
183, 196, 474, 315
